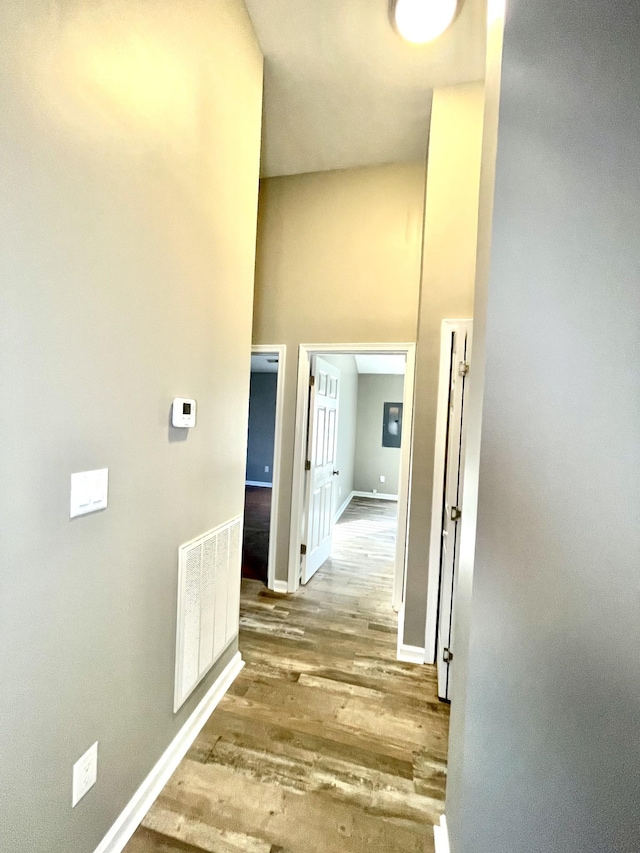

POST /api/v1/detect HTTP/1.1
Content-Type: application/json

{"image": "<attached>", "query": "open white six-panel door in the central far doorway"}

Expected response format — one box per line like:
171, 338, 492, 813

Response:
301, 356, 340, 583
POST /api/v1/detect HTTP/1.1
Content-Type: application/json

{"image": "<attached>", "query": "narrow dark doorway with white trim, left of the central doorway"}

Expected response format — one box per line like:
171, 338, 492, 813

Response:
242, 345, 286, 588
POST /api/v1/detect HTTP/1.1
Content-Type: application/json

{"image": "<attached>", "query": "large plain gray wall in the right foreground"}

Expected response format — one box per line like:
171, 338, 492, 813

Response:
447, 0, 640, 853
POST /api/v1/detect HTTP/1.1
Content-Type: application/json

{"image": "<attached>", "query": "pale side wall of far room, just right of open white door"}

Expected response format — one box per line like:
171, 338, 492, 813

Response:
323, 355, 358, 512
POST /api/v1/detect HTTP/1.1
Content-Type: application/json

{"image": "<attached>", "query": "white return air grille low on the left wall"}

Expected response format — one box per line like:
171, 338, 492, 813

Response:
173, 517, 242, 711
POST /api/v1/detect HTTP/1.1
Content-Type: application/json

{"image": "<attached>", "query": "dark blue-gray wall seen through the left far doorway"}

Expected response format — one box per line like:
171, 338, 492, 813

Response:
247, 373, 278, 483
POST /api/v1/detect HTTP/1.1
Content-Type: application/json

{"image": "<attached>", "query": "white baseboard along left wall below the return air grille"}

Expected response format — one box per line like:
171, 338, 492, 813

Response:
95, 652, 244, 853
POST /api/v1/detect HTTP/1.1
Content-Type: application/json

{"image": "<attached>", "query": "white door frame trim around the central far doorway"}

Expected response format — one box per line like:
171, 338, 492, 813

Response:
287, 343, 416, 611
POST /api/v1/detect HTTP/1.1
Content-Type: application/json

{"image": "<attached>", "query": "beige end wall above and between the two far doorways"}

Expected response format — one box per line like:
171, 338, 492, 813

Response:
253, 163, 424, 584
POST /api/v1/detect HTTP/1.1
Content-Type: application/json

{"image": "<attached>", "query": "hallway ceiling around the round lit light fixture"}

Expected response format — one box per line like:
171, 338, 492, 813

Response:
246, 0, 486, 177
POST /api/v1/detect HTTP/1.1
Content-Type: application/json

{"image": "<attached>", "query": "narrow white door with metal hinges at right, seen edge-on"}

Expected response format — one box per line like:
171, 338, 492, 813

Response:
436, 330, 471, 699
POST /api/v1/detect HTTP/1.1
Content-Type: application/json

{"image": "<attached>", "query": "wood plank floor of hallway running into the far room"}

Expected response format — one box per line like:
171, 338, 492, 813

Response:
126, 498, 449, 853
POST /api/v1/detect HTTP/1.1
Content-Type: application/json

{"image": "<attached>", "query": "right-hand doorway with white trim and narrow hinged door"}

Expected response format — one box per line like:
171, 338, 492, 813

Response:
425, 320, 473, 701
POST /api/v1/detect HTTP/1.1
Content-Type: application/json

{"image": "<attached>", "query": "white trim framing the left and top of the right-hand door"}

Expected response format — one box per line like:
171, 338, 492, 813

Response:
424, 317, 473, 664
